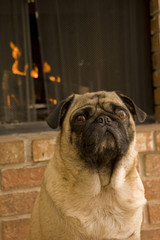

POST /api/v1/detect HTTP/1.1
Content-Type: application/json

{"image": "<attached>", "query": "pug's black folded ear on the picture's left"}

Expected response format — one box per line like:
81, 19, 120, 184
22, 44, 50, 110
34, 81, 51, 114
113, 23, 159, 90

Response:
46, 95, 74, 129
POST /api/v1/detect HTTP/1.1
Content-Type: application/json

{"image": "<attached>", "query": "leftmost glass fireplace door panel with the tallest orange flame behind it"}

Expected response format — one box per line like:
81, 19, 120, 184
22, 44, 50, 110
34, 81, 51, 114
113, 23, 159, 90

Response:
0, 0, 36, 124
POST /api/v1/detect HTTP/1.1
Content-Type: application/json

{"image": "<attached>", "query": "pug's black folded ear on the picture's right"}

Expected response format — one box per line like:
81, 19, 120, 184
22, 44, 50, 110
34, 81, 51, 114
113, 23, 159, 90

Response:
116, 92, 147, 123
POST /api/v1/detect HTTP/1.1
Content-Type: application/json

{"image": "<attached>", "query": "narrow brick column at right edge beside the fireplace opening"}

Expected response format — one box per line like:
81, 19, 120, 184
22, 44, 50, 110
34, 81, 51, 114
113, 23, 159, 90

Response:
150, 0, 160, 122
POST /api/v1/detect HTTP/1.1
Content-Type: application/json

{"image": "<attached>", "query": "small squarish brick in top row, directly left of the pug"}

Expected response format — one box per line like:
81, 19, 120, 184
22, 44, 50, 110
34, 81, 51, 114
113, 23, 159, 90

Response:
32, 139, 55, 161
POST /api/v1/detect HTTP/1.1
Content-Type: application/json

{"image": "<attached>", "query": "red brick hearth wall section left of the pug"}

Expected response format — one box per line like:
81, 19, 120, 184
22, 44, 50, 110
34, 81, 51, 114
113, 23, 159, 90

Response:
0, 132, 57, 240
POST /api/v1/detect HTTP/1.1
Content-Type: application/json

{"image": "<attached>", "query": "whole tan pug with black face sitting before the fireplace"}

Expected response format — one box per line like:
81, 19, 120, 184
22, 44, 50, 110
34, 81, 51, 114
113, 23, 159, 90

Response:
28, 91, 146, 240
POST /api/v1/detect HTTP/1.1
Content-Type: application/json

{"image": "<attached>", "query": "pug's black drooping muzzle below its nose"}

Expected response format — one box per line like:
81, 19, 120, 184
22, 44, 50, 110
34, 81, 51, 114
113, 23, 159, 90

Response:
80, 127, 120, 168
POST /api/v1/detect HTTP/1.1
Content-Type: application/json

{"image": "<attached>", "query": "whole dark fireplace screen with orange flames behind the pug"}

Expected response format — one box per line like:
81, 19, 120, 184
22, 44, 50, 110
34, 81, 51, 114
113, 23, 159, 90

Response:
0, 0, 153, 125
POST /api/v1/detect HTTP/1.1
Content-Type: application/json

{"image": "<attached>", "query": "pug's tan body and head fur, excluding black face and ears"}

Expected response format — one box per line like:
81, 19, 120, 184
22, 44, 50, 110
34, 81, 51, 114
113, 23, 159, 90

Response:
28, 92, 145, 240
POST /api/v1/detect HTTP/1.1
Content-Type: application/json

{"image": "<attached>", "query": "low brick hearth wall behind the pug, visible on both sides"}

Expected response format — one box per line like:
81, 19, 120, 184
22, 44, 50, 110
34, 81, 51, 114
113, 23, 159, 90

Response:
0, 125, 160, 240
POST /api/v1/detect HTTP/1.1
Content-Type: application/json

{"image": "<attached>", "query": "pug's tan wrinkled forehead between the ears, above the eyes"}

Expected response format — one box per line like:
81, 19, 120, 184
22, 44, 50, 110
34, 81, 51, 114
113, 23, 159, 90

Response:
72, 91, 125, 110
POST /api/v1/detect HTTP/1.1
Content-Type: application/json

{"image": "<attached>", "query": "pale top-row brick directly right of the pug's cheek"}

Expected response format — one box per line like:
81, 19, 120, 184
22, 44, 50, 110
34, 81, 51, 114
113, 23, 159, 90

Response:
136, 132, 154, 152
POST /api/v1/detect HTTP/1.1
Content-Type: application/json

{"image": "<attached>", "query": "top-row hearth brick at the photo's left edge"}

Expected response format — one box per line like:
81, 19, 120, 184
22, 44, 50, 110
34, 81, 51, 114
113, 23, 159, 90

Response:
0, 141, 25, 164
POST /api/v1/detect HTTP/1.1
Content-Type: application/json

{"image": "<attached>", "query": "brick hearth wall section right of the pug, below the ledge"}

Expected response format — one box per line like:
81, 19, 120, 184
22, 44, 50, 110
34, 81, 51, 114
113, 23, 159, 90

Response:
137, 124, 160, 240
